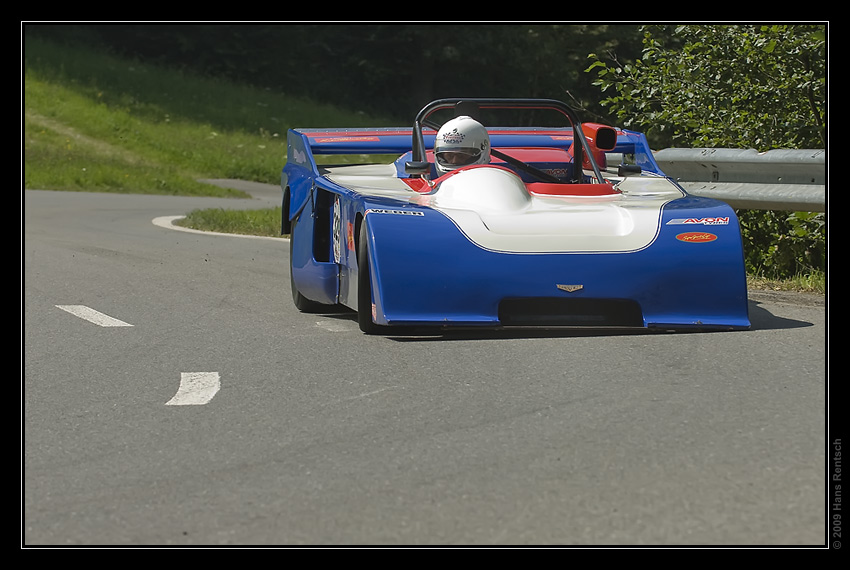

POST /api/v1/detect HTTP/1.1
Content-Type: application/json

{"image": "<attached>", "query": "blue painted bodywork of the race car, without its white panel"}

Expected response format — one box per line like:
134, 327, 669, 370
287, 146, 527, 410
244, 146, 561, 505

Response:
281, 101, 750, 332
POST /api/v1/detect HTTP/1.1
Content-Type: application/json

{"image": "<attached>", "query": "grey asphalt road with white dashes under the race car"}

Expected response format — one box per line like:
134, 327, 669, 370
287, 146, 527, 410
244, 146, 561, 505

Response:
21, 187, 831, 547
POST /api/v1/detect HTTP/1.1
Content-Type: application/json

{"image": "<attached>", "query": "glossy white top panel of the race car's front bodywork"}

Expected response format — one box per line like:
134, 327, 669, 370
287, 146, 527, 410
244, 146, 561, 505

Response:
327, 165, 685, 253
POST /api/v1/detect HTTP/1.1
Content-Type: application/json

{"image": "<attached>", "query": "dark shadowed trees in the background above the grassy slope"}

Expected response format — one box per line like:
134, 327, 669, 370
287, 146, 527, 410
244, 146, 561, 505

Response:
26, 23, 640, 124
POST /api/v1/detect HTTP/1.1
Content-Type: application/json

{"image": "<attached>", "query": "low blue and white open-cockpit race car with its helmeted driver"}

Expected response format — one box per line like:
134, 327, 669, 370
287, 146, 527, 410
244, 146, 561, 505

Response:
281, 99, 750, 334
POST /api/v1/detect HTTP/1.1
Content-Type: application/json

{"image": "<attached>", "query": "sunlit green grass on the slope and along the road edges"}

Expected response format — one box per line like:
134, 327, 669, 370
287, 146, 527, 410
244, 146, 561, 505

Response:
23, 33, 825, 293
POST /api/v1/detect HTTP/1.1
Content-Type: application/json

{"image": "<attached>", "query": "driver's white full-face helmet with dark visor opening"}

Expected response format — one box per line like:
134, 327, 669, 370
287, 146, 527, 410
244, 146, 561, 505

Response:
434, 116, 490, 174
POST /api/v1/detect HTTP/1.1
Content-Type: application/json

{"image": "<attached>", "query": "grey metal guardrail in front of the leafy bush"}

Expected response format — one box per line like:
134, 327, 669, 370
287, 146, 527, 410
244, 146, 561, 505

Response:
655, 148, 826, 212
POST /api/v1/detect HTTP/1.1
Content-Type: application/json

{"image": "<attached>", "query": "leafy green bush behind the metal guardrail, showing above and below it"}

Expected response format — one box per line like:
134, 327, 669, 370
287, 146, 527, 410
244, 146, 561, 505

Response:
586, 25, 826, 278
